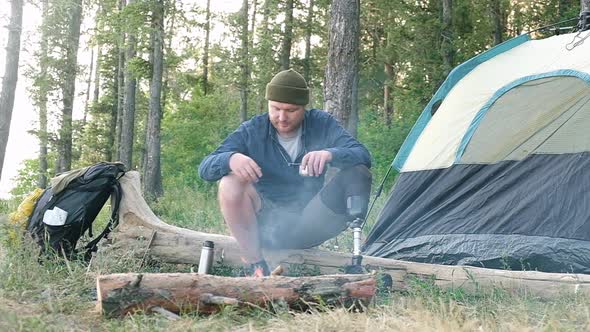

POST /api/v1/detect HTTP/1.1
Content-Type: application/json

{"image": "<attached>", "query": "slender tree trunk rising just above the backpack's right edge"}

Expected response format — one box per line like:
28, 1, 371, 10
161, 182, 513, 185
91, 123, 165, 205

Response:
114, 0, 129, 162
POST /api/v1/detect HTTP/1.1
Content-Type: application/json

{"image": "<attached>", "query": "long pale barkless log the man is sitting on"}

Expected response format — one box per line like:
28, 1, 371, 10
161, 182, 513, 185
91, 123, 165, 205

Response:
105, 172, 590, 297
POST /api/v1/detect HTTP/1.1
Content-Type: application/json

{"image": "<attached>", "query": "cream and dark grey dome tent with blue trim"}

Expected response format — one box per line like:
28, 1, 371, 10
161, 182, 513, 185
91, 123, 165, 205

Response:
364, 31, 590, 273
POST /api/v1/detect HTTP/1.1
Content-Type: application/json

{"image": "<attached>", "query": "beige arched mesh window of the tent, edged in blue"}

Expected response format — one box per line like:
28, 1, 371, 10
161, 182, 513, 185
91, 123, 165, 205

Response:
460, 76, 590, 164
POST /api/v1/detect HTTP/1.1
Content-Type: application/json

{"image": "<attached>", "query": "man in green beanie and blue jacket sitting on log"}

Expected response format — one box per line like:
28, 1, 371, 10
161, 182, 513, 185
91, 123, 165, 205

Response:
199, 69, 371, 276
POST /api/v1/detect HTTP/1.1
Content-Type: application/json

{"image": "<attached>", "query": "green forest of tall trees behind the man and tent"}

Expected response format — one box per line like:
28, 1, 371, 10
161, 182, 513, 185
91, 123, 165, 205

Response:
0, 0, 580, 202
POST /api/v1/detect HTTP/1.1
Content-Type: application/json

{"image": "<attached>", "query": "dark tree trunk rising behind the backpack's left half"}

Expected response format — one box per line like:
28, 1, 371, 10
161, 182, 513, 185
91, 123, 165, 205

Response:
59, 0, 82, 172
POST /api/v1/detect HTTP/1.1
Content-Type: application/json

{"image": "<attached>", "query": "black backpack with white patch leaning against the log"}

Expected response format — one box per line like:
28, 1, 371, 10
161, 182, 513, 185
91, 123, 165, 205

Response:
27, 162, 125, 260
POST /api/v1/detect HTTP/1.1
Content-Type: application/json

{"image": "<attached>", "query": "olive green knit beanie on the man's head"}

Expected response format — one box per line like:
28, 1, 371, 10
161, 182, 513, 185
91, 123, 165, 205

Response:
266, 69, 309, 106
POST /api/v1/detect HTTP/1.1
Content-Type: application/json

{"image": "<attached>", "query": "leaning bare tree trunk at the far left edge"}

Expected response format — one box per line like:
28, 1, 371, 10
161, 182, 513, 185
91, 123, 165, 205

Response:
0, 0, 23, 182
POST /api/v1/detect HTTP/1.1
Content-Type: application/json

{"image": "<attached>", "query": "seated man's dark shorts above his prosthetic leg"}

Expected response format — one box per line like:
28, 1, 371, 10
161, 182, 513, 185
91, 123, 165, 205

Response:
257, 166, 371, 249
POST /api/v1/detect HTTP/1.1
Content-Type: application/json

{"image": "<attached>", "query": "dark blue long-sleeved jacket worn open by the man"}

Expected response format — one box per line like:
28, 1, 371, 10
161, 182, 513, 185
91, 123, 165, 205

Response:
199, 109, 371, 204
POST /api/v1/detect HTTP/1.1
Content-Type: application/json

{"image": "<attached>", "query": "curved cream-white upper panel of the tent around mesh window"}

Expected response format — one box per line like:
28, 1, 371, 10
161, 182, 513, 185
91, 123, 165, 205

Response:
402, 31, 590, 172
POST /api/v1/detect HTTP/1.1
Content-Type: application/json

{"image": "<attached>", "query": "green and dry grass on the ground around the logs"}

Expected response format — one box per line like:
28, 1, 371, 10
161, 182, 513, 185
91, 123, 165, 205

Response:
0, 189, 590, 331
